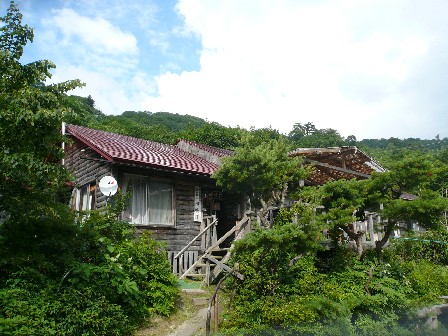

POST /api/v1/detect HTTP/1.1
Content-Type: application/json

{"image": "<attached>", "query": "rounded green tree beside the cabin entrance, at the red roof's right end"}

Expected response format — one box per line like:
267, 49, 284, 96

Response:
213, 133, 307, 226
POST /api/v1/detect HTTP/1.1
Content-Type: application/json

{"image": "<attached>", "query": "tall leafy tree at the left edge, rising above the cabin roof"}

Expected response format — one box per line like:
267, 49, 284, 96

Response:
0, 3, 82, 215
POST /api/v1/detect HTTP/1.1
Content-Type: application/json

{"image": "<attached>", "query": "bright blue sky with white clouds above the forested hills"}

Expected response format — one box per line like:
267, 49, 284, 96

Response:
0, 0, 448, 140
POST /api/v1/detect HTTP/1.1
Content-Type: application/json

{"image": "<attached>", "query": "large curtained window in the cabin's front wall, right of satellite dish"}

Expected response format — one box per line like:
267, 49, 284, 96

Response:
123, 175, 174, 225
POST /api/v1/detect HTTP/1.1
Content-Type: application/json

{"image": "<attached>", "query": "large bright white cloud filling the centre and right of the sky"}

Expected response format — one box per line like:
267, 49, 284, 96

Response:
143, 0, 440, 138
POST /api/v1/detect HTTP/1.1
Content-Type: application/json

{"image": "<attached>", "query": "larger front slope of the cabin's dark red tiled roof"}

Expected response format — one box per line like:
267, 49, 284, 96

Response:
66, 124, 218, 175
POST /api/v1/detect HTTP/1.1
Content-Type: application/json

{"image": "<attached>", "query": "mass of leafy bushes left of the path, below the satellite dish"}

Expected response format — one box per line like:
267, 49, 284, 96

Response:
0, 201, 178, 335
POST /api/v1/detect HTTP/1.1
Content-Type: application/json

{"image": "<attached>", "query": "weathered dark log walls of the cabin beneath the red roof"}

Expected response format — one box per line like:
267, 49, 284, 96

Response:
65, 139, 219, 258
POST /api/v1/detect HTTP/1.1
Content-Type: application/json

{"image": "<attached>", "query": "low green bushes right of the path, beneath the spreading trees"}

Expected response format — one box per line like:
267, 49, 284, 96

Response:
223, 223, 448, 336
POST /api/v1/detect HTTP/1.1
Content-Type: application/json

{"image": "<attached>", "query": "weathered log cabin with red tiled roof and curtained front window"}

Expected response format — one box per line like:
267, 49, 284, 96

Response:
63, 124, 248, 273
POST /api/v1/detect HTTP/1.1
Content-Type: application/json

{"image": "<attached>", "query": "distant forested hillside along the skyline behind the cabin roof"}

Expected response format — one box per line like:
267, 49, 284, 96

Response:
67, 95, 448, 157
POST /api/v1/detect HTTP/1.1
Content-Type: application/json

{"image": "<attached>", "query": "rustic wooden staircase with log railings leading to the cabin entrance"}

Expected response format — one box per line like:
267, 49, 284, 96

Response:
174, 214, 251, 286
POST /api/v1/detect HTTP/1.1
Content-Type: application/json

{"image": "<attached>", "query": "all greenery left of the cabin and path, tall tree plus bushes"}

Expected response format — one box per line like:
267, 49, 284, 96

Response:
0, 3, 177, 335
